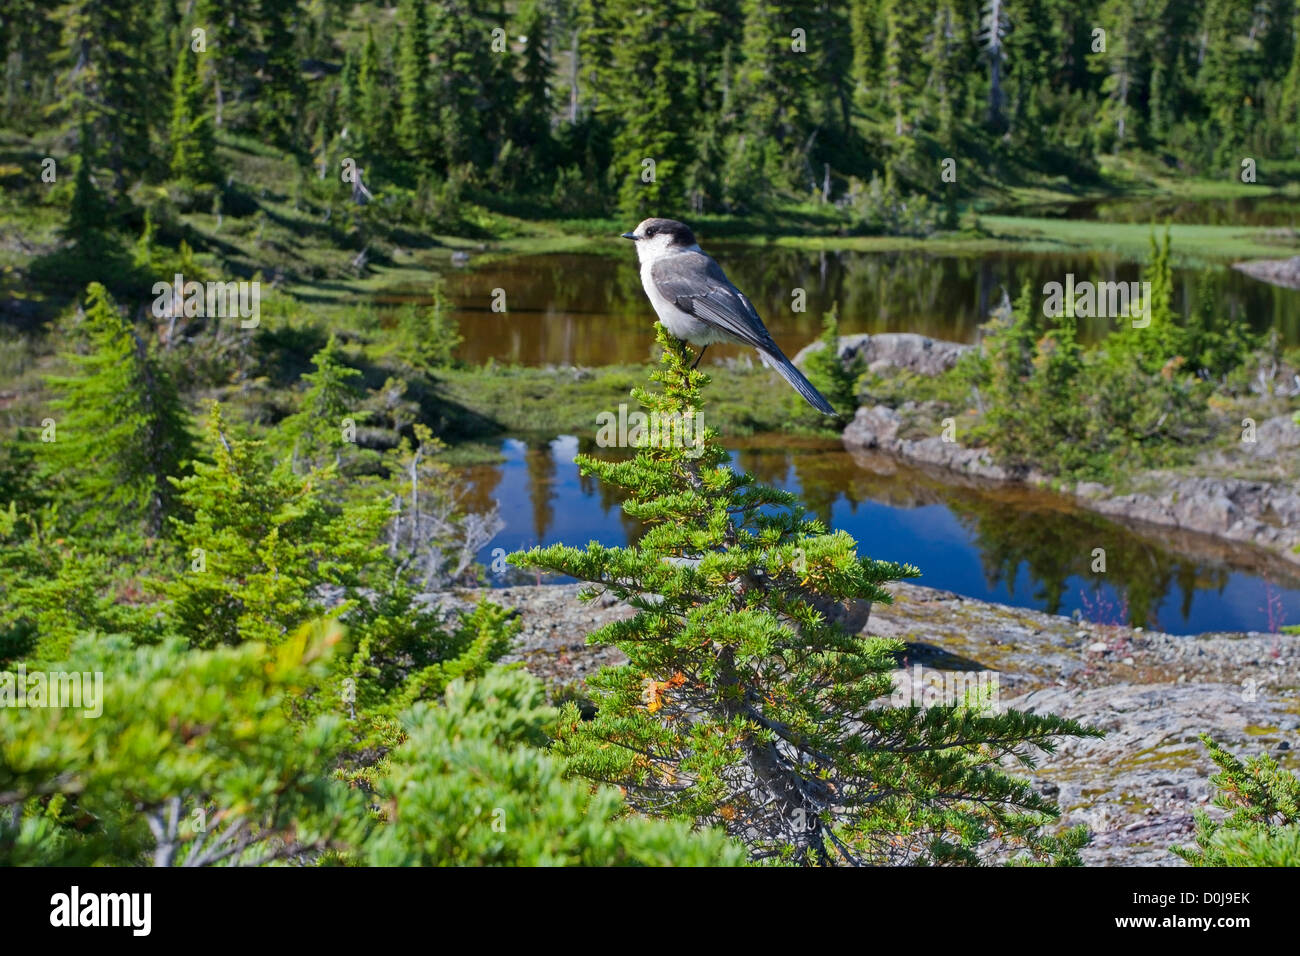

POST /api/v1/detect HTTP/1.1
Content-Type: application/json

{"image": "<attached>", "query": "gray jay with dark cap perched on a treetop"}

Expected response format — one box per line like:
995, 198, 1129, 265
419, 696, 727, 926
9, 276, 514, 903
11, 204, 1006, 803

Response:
623, 219, 835, 415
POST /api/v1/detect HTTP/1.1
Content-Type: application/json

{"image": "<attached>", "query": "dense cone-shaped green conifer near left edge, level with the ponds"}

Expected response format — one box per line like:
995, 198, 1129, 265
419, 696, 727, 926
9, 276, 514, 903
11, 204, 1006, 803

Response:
43, 282, 192, 536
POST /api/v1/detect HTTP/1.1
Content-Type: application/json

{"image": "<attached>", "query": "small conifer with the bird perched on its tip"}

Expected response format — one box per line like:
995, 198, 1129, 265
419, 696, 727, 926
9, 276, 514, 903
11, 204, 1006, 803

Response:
511, 330, 1096, 865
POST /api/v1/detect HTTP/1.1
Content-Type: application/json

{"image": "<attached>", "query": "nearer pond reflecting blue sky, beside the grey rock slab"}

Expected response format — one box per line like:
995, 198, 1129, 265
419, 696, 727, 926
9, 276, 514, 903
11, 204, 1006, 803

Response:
465, 436, 1300, 633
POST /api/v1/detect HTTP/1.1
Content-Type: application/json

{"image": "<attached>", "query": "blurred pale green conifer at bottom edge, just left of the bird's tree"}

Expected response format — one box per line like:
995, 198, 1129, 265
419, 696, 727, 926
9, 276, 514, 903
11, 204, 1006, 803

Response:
364, 669, 745, 866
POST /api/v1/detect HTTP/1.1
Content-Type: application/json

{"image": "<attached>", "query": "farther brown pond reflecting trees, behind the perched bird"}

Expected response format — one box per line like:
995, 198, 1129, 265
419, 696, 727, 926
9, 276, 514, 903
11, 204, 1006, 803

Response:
377, 241, 1300, 365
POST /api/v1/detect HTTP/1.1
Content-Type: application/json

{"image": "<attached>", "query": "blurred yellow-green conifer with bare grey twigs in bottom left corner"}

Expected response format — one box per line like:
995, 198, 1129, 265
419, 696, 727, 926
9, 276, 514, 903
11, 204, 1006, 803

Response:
0, 632, 365, 866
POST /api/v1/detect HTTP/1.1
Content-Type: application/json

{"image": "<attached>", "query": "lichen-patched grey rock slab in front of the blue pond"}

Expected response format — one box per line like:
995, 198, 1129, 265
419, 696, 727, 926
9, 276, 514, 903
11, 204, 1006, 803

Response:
429, 583, 1300, 866
